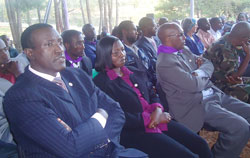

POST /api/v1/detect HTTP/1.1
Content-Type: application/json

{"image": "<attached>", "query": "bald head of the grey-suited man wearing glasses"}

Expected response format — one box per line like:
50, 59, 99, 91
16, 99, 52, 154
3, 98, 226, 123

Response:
157, 23, 185, 50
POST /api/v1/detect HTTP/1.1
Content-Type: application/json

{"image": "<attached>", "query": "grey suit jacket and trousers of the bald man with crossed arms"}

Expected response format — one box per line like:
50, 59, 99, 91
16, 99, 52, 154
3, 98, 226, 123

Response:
156, 48, 250, 158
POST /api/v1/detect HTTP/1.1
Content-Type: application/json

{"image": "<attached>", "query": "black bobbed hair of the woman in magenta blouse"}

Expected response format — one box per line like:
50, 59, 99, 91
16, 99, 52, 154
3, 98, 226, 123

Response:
95, 36, 119, 72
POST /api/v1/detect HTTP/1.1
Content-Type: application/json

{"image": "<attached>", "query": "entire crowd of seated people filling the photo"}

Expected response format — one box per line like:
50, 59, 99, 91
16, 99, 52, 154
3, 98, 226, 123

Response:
0, 13, 250, 158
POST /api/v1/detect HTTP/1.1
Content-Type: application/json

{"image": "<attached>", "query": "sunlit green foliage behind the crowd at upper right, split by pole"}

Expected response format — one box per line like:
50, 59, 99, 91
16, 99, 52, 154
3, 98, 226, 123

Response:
156, 0, 250, 20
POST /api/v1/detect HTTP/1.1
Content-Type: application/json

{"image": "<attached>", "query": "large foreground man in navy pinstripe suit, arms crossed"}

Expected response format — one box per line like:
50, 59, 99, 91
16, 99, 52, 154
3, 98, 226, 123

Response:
4, 24, 145, 158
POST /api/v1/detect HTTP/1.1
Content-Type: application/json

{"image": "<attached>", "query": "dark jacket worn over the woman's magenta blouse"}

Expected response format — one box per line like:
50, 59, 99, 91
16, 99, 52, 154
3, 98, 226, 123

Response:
93, 69, 159, 132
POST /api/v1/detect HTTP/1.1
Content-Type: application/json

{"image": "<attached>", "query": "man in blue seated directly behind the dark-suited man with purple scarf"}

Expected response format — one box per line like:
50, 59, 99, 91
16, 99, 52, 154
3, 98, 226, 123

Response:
82, 24, 97, 68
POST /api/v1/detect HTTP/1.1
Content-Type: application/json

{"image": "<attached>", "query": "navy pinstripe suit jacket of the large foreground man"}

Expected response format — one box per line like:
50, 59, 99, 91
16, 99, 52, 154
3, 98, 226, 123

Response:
4, 68, 124, 158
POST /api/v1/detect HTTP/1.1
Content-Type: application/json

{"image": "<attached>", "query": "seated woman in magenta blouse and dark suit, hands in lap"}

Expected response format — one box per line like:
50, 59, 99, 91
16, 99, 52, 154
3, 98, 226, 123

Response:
94, 36, 212, 158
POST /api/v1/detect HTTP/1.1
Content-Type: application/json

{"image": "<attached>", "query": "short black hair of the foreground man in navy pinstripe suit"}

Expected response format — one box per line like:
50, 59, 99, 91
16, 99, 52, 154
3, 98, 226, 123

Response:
21, 23, 53, 49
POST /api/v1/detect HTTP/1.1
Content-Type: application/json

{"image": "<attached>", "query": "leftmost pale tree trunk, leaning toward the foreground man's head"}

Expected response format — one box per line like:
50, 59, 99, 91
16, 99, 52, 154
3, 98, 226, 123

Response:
5, 0, 22, 52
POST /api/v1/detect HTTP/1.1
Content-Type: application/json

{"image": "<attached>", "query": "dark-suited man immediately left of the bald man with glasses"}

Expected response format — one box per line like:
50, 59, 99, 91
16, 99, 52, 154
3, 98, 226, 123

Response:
136, 17, 158, 85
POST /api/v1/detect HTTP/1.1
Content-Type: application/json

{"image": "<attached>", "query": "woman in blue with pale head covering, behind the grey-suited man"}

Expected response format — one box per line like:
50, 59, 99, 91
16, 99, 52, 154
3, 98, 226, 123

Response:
182, 18, 204, 55
